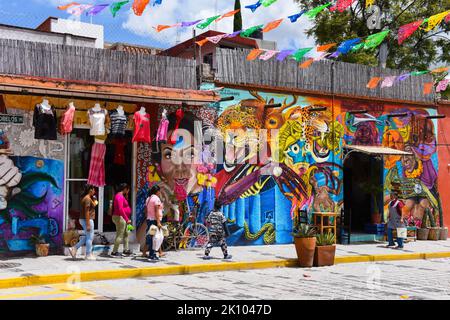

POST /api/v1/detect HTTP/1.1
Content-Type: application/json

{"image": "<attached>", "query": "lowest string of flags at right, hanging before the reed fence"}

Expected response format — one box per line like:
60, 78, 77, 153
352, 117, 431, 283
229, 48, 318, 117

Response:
366, 67, 450, 95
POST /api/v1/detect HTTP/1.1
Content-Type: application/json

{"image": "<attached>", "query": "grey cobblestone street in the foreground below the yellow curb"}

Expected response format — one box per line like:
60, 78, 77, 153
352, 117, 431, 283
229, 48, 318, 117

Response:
0, 259, 450, 300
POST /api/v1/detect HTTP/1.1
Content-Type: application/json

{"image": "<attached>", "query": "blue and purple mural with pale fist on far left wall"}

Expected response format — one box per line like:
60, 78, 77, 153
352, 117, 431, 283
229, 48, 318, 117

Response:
0, 155, 64, 252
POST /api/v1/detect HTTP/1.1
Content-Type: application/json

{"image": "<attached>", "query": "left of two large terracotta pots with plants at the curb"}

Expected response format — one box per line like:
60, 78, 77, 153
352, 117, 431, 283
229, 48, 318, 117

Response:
292, 223, 316, 268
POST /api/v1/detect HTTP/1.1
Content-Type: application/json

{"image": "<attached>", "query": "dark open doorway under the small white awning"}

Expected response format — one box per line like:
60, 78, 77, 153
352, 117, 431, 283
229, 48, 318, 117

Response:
344, 152, 383, 234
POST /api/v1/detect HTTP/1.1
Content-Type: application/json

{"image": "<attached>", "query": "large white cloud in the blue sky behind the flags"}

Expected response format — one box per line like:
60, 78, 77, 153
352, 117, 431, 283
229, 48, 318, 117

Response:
121, 0, 314, 49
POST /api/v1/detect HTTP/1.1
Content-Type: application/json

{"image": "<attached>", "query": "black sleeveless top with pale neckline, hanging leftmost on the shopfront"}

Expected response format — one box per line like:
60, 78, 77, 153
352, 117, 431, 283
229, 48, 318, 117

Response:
33, 104, 57, 140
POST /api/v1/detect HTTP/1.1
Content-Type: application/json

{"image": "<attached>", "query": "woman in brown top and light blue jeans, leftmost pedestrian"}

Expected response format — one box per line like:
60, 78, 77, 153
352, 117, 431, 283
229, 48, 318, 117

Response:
69, 185, 98, 260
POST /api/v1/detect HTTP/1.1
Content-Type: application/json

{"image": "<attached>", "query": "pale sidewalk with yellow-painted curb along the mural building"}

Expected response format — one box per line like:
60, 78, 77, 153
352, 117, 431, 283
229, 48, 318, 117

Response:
0, 240, 450, 288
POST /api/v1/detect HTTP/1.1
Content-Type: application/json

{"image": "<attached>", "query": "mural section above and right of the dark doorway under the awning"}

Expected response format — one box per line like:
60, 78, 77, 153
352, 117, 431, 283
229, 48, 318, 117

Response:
341, 106, 442, 227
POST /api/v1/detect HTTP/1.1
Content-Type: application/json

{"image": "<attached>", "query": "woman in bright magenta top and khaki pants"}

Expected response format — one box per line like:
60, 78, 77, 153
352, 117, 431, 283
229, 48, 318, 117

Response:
111, 183, 132, 257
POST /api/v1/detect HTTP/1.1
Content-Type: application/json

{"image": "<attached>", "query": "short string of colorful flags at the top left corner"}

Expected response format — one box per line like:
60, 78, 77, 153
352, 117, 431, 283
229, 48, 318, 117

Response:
57, 0, 162, 17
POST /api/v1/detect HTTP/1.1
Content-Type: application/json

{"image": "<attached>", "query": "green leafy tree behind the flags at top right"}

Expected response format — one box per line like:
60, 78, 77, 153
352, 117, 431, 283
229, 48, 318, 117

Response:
294, 0, 450, 70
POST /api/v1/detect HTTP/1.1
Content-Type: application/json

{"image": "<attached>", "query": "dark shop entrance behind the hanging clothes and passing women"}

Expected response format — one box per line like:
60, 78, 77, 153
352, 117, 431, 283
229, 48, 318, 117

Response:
66, 128, 135, 232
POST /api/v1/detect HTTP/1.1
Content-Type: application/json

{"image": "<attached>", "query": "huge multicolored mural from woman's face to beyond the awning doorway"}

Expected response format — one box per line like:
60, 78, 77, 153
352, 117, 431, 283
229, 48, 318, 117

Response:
134, 88, 442, 245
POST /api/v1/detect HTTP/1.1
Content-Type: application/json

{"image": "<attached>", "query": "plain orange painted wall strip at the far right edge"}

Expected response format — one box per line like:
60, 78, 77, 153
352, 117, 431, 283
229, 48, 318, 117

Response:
438, 106, 450, 227
